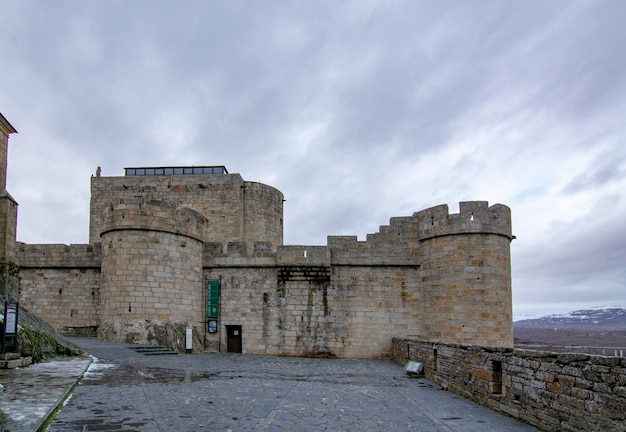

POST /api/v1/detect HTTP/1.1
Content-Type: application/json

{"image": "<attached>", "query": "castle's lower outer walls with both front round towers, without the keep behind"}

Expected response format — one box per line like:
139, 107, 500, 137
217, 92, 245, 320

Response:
18, 199, 512, 358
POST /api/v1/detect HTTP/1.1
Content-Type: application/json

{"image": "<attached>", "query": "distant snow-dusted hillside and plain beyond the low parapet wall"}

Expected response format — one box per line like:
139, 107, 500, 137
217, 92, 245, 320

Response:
513, 307, 626, 356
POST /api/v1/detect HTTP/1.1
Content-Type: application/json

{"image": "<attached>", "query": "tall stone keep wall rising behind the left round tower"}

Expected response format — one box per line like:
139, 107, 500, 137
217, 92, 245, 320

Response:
89, 174, 283, 252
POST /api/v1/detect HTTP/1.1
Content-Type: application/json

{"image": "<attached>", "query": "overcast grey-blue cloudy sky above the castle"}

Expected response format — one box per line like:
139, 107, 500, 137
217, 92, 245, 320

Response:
0, 0, 626, 315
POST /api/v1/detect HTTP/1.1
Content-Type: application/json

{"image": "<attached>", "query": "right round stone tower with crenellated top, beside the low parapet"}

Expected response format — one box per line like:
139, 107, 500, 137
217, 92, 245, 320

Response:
414, 201, 513, 347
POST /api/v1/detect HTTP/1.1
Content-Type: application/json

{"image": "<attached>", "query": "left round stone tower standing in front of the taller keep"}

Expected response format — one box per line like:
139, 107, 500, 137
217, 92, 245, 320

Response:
98, 201, 207, 349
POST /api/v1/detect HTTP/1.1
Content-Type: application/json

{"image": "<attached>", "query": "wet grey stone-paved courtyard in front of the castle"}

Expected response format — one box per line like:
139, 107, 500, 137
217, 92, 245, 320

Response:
47, 338, 535, 432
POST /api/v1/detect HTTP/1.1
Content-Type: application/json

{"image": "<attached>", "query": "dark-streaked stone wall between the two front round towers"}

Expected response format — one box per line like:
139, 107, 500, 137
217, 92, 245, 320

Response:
205, 246, 420, 358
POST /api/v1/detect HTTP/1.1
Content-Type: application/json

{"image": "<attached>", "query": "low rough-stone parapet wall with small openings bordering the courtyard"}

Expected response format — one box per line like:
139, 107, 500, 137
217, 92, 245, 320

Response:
392, 339, 626, 431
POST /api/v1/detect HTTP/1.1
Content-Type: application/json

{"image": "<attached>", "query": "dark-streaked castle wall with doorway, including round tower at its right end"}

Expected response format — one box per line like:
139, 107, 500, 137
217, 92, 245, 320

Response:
204, 202, 513, 357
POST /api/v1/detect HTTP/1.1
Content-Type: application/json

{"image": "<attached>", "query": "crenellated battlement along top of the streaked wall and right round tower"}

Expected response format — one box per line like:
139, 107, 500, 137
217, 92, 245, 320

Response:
204, 201, 513, 266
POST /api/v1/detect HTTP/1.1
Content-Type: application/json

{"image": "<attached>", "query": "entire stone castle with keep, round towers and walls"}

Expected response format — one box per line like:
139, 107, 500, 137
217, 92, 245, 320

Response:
0, 112, 513, 358
